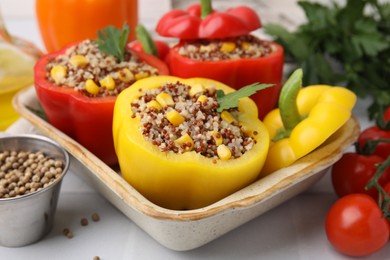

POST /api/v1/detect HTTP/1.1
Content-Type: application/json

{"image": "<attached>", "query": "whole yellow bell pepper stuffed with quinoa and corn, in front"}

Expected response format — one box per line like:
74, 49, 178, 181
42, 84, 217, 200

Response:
113, 76, 269, 210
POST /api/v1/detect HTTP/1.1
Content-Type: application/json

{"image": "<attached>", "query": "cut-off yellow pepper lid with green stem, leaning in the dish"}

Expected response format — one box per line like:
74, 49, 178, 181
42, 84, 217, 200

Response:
261, 69, 356, 176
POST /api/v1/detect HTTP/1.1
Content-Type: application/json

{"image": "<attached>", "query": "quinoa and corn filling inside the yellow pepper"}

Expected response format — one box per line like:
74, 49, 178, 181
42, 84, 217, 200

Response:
131, 82, 258, 160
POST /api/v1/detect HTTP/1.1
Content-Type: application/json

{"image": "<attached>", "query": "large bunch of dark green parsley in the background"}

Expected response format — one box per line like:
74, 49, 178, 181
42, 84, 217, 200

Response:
264, 0, 390, 118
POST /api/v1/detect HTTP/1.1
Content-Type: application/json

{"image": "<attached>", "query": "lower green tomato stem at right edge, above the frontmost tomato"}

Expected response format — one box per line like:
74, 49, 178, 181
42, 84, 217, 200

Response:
365, 156, 390, 220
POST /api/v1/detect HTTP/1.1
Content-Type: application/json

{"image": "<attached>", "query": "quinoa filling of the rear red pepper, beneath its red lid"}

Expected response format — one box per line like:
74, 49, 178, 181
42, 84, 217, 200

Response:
178, 35, 275, 61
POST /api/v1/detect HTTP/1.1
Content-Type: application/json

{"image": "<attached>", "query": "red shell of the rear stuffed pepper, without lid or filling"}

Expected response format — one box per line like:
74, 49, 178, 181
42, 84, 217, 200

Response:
168, 42, 284, 119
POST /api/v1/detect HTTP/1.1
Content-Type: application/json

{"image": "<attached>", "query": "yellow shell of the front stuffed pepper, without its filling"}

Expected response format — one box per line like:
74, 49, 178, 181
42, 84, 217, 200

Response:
113, 76, 269, 210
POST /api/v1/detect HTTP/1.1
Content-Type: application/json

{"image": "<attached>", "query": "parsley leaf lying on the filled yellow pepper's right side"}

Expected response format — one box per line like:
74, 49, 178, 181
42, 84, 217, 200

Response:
217, 83, 274, 112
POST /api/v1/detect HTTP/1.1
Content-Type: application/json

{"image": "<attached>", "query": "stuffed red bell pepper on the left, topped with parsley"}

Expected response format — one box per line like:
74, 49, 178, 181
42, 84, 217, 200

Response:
34, 27, 168, 165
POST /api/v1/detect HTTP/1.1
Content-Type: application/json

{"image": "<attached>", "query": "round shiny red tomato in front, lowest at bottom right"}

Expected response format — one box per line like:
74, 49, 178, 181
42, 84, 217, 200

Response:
325, 194, 390, 256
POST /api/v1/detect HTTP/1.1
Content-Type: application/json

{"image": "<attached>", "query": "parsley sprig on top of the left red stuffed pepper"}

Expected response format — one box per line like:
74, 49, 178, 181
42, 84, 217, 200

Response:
96, 24, 130, 61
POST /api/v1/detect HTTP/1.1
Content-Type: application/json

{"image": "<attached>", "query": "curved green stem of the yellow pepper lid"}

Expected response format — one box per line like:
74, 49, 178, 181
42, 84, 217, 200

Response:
279, 69, 303, 136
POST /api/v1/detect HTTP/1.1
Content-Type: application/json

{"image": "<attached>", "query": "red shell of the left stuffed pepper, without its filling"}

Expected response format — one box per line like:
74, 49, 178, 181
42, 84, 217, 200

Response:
34, 43, 168, 165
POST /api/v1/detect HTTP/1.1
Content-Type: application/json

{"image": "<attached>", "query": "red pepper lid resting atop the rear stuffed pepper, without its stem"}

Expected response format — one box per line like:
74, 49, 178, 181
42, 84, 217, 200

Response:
156, 4, 261, 40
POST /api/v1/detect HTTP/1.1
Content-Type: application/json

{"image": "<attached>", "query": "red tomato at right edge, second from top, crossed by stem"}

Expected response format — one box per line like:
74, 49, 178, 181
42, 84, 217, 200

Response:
358, 126, 390, 159
